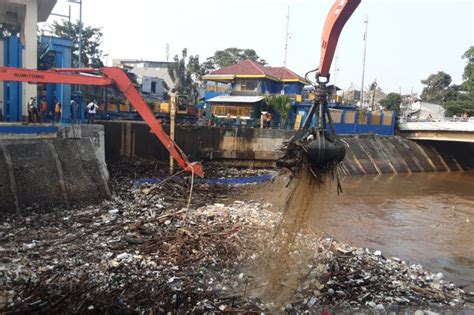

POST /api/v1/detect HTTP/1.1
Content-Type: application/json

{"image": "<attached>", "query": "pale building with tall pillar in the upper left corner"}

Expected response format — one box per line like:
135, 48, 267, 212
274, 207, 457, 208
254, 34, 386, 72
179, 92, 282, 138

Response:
0, 0, 57, 120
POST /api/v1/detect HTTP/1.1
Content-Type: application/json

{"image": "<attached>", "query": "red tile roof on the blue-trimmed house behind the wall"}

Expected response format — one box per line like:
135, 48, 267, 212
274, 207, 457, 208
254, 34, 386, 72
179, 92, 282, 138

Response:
209, 60, 308, 84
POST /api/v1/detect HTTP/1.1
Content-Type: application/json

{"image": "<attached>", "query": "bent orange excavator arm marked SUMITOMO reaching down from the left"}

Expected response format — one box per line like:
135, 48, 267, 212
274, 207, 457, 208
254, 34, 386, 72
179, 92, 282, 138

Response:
0, 67, 204, 177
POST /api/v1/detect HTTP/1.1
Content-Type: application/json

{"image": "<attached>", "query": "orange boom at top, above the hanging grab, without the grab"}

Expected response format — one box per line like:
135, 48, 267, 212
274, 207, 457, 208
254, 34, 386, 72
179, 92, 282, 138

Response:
316, 0, 361, 80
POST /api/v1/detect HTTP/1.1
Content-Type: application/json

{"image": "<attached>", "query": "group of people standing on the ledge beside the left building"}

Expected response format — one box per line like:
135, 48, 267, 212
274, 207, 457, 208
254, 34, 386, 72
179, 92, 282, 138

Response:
27, 97, 99, 124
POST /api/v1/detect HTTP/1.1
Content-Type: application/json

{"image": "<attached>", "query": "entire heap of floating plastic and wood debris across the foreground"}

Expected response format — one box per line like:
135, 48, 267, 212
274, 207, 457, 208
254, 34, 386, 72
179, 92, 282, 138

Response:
0, 160, 474, 314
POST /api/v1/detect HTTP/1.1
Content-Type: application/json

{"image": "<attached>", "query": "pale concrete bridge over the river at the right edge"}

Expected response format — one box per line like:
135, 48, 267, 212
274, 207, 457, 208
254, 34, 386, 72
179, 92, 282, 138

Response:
398, 121, 474, 143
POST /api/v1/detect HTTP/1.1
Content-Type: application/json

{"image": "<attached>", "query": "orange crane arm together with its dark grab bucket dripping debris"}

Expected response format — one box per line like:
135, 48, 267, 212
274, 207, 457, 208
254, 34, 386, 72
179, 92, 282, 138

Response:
278, 0, 361, 170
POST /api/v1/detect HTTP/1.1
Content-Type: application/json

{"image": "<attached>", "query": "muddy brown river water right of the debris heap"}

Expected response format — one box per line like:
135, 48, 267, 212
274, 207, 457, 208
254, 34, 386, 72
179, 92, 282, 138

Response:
311, 172, 474, 291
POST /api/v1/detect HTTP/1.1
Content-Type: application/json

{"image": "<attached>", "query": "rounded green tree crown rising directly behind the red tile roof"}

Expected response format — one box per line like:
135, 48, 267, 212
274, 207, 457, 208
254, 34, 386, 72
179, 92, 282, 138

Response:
201, 47, 267, 75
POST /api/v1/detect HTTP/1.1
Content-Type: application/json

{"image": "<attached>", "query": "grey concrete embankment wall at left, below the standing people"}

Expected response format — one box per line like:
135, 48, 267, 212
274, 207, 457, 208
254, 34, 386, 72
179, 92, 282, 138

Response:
0, 126, 110, 214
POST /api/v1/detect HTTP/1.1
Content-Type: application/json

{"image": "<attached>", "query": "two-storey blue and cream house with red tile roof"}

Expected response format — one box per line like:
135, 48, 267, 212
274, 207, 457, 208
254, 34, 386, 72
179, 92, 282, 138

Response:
202, 60, 309, 123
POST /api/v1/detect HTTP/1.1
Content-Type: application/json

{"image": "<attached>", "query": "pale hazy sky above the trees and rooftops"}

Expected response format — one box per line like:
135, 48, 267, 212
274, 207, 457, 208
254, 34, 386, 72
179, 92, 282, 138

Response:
43, 0, 474, 94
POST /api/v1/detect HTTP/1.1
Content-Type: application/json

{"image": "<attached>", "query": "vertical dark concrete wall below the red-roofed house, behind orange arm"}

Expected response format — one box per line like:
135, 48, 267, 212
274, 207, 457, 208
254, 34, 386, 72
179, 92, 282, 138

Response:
101, 121, 293, 162
